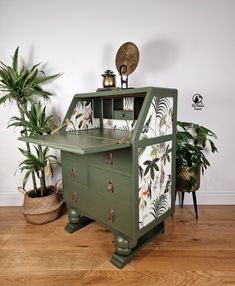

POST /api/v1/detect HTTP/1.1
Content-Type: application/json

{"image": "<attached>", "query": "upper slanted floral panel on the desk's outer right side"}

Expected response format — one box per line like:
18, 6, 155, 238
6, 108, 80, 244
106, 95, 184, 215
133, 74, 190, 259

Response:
140, 97, 173, 140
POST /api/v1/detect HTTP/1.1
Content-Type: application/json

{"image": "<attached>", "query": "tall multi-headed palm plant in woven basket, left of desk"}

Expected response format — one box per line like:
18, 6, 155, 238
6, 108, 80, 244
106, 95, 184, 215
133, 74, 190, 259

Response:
0, 48, 62, 223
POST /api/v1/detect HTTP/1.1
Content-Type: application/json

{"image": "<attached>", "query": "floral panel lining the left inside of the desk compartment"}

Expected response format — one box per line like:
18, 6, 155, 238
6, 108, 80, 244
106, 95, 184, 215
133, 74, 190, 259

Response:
66, 100, 100, 131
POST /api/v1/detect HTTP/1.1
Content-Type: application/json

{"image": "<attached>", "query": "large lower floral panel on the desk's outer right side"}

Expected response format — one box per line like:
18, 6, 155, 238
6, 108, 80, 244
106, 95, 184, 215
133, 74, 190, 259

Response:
138, 141, 172, 229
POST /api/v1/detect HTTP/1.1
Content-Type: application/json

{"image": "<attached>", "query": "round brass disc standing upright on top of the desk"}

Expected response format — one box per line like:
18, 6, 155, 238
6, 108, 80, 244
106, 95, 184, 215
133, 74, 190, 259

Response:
116, 42, 139, 75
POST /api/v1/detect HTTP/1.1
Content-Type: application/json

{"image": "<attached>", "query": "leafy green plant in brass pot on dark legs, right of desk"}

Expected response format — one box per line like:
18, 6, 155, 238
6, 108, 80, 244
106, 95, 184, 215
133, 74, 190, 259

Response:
176, 121, 218, 217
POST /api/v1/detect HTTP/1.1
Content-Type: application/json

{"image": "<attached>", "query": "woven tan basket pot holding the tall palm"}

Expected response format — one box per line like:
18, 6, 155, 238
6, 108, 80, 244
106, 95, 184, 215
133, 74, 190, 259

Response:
21, 186, 63, 224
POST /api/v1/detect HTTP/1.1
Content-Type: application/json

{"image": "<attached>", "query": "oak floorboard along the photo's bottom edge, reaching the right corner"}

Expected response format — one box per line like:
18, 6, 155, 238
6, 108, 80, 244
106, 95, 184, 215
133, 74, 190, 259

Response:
82, 270, 235, 286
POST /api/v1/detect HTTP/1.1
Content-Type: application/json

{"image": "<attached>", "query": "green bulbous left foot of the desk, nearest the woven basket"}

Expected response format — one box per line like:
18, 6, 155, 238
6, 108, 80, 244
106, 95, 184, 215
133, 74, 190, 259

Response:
65, 207, 93, 233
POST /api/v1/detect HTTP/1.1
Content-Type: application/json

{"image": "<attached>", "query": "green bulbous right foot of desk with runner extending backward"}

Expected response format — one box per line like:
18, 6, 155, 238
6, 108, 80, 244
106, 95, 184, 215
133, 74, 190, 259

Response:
111, 222, 165, 268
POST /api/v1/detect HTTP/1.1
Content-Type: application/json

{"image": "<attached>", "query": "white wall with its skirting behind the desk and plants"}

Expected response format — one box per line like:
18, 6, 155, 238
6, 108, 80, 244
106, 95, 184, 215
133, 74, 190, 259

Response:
0, 0, 235, 205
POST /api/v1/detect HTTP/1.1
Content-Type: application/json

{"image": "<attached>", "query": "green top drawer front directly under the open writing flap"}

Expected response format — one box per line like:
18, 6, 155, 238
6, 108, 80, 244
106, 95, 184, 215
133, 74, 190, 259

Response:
61, 148, 132, 175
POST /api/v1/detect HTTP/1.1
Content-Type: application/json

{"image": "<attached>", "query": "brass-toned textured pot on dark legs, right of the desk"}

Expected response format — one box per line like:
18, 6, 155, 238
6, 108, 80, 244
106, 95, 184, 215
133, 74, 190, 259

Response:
176, 166, 201, 192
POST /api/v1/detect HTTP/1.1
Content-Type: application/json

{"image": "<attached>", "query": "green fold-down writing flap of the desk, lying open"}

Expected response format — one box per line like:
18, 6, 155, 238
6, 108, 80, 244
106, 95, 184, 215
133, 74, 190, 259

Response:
19, 129, 130, 154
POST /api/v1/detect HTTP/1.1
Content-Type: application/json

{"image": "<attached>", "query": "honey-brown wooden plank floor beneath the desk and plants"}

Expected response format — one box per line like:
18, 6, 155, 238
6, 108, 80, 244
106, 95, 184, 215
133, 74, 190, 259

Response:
0, 206, 235, 286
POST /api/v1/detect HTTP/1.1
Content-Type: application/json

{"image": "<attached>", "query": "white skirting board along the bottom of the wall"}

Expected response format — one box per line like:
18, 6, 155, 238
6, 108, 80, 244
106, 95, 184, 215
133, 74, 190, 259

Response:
0, 190, 235, 206
